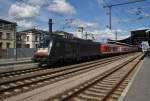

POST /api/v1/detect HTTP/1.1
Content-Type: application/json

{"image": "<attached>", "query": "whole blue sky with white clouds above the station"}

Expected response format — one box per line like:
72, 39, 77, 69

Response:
0, 0, 150, 41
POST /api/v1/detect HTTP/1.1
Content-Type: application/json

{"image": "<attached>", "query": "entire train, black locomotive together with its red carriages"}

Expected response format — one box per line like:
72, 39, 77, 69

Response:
32, 31, 138, 65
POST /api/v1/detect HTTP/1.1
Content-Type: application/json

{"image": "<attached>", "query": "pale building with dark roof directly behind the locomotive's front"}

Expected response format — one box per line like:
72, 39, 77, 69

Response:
17, 28, 49, 48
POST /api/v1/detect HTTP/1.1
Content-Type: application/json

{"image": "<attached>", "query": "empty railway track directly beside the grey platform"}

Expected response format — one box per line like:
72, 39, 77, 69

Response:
49, 52, 143, 101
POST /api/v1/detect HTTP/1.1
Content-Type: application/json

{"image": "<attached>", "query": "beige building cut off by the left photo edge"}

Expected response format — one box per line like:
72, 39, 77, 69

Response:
0, 19, 16, 49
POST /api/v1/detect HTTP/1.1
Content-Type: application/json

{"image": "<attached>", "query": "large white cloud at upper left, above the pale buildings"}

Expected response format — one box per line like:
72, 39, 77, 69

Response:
8, 0, 45, 28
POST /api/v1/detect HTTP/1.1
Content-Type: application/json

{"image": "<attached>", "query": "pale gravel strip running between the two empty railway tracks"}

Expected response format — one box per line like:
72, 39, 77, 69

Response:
5, 52, 142, 101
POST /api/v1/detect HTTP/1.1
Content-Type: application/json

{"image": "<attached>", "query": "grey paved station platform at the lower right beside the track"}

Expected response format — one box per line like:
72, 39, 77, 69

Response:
118, 55, 150, 101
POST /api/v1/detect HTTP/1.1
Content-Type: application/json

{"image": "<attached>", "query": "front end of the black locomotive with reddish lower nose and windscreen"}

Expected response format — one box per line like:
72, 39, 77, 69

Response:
33, 36, 53, 64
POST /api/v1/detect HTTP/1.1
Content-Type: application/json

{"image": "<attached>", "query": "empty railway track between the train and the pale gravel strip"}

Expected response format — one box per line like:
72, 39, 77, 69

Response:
0, 54, 136, 99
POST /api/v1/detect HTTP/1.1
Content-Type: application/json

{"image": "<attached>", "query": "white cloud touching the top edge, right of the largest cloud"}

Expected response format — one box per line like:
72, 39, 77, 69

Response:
48, 0, 76, 14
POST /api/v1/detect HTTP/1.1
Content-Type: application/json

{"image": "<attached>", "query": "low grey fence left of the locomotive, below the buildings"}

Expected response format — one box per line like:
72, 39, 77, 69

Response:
0, 48, 36, 59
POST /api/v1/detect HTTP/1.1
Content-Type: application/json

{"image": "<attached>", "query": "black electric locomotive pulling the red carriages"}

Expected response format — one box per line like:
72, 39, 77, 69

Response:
33, 32, 100, 65
